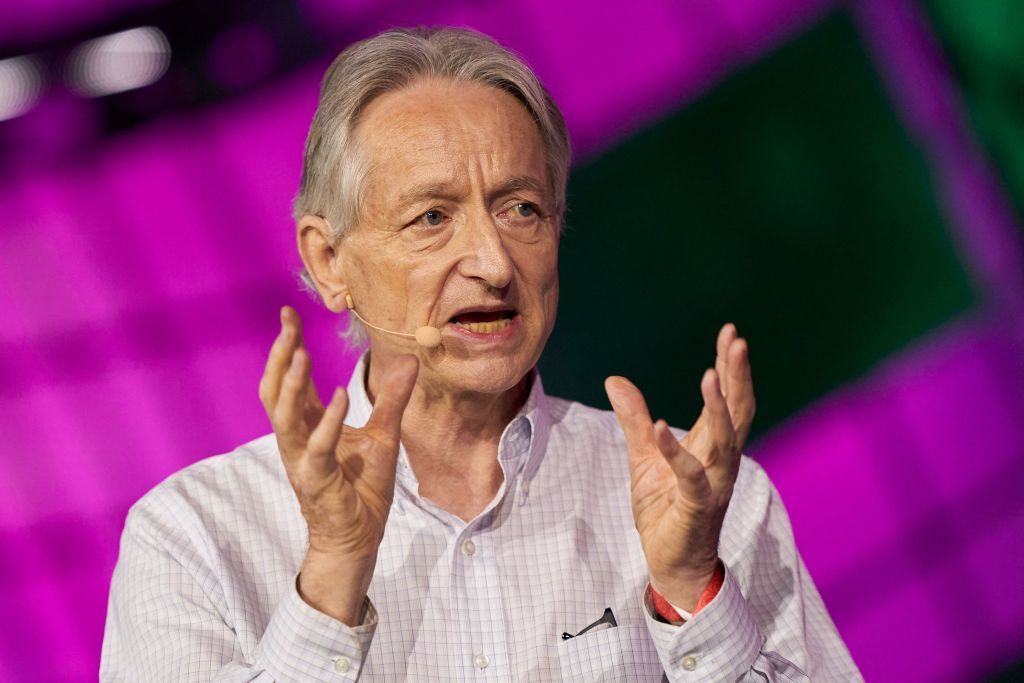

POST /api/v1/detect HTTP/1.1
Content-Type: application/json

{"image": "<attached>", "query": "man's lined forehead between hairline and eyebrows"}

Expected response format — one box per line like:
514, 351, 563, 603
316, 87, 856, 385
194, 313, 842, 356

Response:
356, 79, 546, 197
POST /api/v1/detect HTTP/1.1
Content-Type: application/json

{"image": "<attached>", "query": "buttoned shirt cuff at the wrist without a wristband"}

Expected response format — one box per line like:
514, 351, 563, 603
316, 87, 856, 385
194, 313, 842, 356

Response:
254, 582, 378, 683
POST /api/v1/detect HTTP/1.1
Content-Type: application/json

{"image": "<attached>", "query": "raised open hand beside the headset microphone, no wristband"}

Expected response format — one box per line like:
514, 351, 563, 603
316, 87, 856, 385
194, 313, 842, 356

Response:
259, 306, 419, 626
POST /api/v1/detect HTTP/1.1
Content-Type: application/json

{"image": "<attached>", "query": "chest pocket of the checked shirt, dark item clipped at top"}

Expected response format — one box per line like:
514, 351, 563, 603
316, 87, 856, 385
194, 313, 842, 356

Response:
557, 626, 667, 683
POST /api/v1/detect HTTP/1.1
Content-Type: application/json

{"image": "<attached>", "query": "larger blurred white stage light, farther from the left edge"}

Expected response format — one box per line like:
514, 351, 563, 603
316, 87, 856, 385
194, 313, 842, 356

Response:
68, 27, 171, 97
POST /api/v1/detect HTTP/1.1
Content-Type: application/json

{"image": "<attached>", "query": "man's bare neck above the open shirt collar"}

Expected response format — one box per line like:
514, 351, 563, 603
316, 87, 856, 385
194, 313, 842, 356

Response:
367, 356, 529, 521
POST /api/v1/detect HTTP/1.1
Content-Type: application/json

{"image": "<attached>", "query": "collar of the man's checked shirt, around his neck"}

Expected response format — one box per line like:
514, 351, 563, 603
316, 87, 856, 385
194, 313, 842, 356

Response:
345, 350, 551, 490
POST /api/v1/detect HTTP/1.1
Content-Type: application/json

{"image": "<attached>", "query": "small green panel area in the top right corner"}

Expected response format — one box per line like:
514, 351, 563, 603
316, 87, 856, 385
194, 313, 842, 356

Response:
926, 0, 1024, 229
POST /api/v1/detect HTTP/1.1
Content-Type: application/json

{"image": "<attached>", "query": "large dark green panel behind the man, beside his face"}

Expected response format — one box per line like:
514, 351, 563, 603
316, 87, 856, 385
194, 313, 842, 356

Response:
541, 13, 974, 438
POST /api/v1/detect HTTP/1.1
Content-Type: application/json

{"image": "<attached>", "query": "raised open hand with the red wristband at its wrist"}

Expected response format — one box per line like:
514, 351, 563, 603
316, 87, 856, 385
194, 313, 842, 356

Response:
605, 324, 755, 610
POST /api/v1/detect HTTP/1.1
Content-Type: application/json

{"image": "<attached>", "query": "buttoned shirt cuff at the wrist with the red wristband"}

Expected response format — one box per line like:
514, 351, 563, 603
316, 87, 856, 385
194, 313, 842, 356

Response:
643, 568, 765, 681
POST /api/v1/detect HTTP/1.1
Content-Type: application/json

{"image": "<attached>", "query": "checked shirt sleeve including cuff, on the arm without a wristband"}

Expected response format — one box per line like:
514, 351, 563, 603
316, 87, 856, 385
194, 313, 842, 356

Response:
99, 489, 377, 683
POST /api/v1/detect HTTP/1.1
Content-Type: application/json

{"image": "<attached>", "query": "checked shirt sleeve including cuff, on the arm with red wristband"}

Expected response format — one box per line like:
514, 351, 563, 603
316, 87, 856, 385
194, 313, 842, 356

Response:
643, 462, 863, 683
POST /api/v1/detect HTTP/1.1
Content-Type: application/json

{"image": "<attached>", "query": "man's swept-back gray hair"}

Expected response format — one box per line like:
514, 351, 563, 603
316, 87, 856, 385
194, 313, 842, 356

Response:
293, 28, 571, 345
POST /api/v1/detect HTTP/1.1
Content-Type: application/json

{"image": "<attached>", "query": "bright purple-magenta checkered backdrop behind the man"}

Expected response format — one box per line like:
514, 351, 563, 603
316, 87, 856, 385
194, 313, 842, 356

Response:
0, 0, 1024, 681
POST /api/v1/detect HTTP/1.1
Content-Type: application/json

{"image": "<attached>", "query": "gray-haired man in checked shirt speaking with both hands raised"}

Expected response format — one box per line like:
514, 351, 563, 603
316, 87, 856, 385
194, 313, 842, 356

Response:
101, 30, 859, 681
